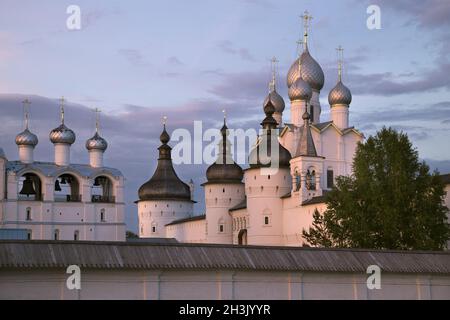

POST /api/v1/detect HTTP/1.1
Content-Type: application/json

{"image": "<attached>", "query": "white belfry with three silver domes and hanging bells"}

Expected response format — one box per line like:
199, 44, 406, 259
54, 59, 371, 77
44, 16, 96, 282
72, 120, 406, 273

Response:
0, 99, 125, 241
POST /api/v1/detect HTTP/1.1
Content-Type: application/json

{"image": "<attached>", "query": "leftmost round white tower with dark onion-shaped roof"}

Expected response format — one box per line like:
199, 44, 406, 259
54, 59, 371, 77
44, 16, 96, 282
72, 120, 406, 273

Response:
137, 120, 194, 238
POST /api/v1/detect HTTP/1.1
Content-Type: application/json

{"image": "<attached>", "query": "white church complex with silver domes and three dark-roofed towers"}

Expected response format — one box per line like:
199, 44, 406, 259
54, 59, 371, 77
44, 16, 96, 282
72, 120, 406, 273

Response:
137, 15, 364, 246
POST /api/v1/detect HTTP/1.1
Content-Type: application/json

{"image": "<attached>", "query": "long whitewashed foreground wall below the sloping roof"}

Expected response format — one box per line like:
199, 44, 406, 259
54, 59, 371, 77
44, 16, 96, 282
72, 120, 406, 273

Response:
0, 269, 450, 300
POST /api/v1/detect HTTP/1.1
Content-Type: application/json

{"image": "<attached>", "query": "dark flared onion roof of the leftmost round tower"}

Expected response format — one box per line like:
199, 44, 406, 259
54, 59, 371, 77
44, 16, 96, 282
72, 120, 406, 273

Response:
138, 125, 191, 201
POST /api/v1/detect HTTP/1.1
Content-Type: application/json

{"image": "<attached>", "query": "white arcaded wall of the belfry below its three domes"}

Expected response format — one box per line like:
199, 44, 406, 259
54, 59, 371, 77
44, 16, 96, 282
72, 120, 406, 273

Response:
0, 168, 125, 241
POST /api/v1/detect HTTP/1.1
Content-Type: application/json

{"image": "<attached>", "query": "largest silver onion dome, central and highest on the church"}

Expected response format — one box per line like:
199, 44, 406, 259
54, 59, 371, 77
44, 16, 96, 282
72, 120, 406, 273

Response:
287, 49, 325, 91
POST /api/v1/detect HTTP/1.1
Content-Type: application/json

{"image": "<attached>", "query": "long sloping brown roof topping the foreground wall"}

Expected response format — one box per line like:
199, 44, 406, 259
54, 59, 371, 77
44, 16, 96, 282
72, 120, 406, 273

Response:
0, 240, 450, 274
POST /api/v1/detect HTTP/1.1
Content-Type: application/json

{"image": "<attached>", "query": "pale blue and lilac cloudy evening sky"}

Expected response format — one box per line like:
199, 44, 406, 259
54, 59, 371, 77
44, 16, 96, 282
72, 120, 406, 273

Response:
0, 0, 450, 231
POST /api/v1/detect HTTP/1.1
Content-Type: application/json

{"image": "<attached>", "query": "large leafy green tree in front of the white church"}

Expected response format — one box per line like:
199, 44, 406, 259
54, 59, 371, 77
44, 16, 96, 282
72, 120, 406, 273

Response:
303, 128, 450, 250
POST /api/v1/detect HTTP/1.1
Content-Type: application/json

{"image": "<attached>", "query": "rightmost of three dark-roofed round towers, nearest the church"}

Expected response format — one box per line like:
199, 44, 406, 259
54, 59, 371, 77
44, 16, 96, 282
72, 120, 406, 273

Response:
244, 100, 291, 245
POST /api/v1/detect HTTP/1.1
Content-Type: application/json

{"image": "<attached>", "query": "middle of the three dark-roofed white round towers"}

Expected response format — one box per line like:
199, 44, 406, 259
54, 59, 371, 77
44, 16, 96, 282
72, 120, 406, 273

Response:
202, 117, 245, 243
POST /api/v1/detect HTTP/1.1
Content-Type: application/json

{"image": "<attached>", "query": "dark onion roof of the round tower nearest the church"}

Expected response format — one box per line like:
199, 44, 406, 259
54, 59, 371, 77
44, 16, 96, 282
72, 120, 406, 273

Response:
248, 100, 291, 168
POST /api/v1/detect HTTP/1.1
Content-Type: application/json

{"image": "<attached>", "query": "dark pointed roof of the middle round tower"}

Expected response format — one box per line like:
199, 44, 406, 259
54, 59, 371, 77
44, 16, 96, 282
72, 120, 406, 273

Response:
206, 119, 244, 183
